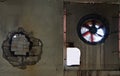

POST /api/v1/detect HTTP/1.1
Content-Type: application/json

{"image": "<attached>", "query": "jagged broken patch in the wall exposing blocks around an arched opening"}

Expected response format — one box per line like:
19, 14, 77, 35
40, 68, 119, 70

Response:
2, 28, 43, 69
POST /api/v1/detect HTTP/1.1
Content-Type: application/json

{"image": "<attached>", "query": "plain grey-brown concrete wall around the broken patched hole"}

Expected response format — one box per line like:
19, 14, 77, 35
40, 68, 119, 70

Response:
0, 0, 63, 76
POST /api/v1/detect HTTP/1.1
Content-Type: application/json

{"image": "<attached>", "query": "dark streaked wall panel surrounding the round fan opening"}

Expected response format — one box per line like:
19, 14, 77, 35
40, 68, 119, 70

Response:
66, 3, 119, 70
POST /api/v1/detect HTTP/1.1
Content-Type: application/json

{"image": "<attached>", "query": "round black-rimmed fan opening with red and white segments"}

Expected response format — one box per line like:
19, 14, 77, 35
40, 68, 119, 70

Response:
77, 14, 109, 45
